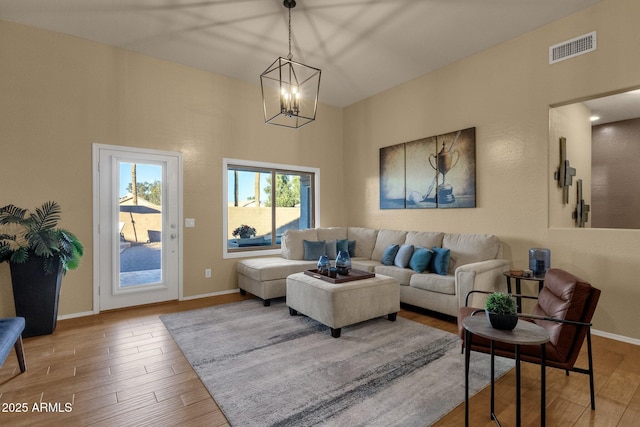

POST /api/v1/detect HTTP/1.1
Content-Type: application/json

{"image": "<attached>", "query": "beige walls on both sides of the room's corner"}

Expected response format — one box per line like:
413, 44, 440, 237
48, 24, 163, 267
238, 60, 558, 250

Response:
0, 0, 640, 339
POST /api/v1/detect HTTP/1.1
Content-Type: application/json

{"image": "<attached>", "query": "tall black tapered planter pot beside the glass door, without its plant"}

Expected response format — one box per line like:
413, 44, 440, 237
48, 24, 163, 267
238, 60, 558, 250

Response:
10, 255, 62, 338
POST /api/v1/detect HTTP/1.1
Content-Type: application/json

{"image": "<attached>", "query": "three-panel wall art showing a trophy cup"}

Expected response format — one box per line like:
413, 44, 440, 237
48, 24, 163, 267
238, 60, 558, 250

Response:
380, 127, 476, 209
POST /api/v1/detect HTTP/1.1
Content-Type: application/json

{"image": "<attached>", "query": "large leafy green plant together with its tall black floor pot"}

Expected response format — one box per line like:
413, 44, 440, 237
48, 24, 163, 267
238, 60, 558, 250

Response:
0, 201, 84, 338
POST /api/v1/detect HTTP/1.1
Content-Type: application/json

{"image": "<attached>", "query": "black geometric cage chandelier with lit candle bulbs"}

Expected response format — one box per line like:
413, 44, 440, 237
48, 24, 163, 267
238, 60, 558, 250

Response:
260, 0, 322, 128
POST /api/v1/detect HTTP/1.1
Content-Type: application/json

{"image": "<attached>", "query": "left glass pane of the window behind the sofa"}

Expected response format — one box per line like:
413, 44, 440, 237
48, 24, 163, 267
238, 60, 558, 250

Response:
227, 168, 272, 248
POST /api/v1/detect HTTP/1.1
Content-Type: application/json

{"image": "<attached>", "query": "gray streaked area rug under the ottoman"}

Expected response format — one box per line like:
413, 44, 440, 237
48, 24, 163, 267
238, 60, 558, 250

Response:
161, 300, 513, 426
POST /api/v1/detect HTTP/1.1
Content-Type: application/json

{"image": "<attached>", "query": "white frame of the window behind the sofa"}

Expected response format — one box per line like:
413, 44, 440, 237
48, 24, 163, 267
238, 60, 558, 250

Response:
222, 158, 320, 259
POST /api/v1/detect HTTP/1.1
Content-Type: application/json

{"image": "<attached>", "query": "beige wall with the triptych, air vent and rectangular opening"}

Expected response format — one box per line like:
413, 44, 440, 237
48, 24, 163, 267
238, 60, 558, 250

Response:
344, 0, 640, 339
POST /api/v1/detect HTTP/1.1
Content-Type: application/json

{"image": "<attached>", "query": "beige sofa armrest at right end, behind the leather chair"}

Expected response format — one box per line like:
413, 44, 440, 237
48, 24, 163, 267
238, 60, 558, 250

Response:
455, 259, 510, 307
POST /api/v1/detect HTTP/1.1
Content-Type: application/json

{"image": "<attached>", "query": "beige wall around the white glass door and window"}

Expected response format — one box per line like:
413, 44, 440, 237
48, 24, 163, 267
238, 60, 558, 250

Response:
0, 21, 344, 315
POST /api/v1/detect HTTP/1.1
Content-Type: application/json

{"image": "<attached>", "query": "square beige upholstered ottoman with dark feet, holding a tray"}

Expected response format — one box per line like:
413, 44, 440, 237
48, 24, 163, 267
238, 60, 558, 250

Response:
287, 272, 400, 338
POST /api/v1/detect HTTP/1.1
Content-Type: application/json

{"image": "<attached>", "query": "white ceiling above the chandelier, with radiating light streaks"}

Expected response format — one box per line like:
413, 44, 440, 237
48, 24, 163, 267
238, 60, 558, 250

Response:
0, 0, 600, 106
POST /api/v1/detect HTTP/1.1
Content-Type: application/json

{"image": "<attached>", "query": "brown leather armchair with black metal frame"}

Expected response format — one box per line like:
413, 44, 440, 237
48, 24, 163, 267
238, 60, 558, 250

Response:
458, 269, 600, 409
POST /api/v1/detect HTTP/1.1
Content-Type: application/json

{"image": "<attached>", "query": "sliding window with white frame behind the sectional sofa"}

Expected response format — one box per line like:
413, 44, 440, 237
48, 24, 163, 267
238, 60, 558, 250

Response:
223, 159, 320, 257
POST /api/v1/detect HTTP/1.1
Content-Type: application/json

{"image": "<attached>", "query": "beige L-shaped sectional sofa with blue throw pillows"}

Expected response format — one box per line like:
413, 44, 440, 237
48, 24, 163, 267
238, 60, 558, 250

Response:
237, 227, 509, 316
